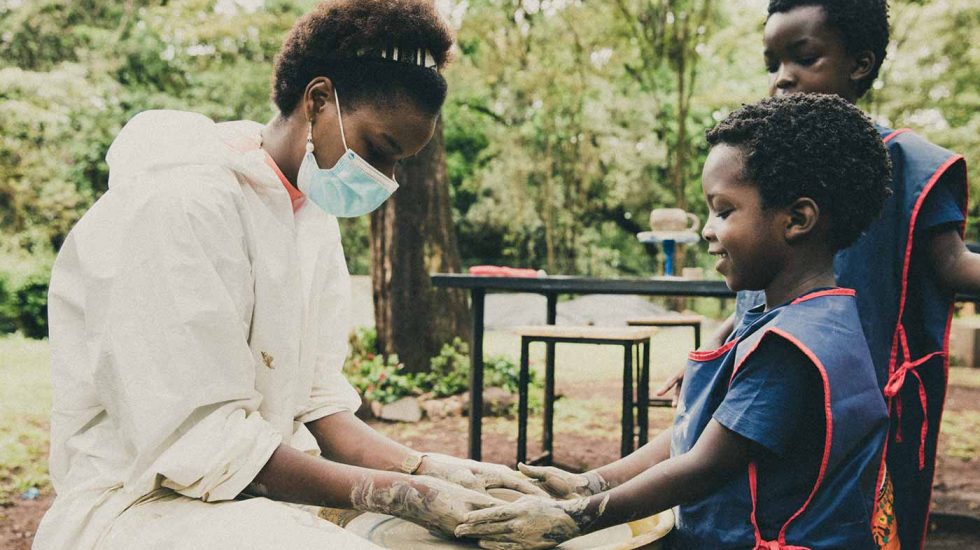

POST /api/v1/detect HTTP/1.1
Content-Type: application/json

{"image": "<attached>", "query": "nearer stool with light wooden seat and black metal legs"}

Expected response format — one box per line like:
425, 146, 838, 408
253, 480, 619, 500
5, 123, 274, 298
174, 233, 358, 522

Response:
513, 325, 657, 464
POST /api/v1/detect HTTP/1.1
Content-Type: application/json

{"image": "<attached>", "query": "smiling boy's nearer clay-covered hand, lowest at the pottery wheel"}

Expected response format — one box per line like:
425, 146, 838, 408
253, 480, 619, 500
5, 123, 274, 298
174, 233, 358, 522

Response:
456, 497, 588, 550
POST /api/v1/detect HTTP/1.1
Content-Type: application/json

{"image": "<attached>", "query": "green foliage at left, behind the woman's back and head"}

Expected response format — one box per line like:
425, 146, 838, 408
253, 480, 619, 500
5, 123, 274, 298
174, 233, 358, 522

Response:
0, 0, 310, 336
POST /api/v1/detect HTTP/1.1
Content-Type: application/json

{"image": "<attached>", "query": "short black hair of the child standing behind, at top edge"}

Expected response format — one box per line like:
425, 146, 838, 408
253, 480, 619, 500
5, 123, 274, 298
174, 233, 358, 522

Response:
769, 0, 888, 97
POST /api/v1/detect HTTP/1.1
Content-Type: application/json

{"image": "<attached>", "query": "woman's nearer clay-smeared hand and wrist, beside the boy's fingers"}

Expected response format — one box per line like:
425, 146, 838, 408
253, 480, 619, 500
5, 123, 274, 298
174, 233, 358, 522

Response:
351, 476, 506, 538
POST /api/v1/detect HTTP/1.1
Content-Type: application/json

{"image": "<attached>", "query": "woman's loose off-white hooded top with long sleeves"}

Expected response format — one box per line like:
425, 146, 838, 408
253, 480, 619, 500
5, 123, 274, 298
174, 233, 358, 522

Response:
35, 111, 368, 550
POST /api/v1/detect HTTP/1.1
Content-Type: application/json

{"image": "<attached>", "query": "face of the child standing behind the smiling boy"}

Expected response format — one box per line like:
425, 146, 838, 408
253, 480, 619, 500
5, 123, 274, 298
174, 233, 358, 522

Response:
763, 6, 860, 103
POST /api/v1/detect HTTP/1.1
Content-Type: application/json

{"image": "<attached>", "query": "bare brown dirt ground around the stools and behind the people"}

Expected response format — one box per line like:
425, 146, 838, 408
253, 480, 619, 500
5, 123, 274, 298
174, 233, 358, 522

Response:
0, 381, 980, 550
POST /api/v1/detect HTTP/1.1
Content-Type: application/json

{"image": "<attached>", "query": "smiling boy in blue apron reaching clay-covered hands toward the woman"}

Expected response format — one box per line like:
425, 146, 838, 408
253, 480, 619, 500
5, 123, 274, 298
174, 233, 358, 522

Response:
456, 94, 889, 549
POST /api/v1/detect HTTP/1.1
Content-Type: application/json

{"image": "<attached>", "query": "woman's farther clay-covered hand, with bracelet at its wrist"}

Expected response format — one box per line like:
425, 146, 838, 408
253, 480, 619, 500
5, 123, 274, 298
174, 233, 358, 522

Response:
418, 454, 548, 496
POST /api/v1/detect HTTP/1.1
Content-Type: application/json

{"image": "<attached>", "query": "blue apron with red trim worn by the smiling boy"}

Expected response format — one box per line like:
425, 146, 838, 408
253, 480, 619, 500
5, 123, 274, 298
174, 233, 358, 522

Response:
671, 289, 888, 550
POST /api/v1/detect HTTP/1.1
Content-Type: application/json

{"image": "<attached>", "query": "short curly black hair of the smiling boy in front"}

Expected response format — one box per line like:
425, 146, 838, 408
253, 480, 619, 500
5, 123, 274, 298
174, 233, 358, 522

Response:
707, 94, 891, 250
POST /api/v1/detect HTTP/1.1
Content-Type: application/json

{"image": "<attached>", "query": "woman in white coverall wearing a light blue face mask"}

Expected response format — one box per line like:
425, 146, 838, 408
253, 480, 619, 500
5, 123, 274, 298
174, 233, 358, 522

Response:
35, 0, 540, 550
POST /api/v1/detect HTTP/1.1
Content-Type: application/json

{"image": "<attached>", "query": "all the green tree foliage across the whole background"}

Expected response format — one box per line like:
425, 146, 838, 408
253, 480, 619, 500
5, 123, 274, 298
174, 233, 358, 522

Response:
0, 0, 980, 334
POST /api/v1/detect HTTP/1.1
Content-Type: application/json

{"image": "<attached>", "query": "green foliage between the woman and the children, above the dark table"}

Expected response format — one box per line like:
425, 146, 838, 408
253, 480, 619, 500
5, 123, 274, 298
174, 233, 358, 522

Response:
446, 0, 744, 276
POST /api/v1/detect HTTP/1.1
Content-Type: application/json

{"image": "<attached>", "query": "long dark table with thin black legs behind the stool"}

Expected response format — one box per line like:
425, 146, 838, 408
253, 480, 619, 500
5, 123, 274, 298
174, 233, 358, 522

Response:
432, 273, 735, 460
